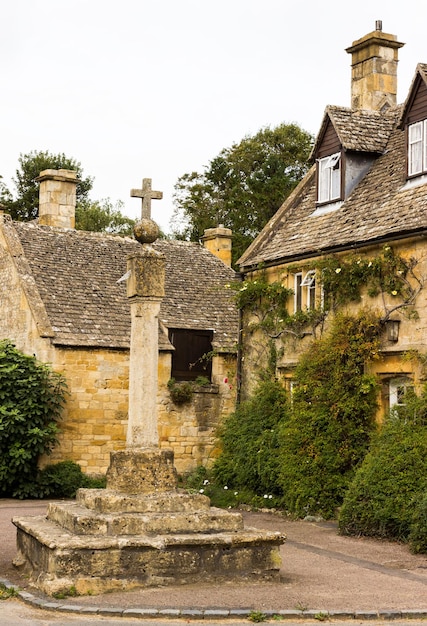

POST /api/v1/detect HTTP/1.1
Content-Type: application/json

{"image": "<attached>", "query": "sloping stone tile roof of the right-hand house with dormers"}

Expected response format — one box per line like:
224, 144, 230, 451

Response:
239, 103, 427, 270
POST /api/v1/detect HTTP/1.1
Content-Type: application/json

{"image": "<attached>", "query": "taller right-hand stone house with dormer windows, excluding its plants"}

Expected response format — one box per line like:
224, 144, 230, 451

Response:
239, 22, 427, 419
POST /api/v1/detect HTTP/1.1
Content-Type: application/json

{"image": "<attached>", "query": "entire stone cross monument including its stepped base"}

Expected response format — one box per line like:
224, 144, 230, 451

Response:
13, 179, 285, 595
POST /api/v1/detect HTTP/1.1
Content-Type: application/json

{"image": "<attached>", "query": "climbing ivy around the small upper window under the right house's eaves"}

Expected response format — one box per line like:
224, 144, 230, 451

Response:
232, 245, 424, 352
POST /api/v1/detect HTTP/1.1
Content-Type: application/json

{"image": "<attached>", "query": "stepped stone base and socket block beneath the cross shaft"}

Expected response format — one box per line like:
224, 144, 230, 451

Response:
13, 450, 285, 595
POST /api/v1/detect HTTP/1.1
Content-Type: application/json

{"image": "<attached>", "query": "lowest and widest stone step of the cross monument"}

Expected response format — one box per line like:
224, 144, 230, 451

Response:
13, 516, 285, 595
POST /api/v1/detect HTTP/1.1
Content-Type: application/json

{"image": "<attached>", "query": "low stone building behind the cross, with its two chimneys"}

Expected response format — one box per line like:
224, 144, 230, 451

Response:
0, 170, 238, 474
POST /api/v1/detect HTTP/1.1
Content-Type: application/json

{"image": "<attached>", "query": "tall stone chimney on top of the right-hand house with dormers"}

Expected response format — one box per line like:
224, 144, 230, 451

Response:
346, 20, 405, 111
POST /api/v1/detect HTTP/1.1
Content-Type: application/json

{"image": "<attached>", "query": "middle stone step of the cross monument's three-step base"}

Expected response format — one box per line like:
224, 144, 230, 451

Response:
47, 502, 243, 536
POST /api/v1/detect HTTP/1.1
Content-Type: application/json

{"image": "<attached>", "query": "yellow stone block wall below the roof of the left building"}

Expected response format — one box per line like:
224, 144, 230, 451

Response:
42, 348, 235, 474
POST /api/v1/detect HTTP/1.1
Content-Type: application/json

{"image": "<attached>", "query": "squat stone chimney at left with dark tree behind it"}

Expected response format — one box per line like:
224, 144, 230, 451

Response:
36, 169, 79, 228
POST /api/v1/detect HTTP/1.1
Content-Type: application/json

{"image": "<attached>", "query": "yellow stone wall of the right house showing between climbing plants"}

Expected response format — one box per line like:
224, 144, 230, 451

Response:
242, 238, 427, 421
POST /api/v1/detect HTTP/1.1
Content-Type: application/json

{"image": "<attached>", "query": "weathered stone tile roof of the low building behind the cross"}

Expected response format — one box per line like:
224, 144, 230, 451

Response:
4, 220, 238, 349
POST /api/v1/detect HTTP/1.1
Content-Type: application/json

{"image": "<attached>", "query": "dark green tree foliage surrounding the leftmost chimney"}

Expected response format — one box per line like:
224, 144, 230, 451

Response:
2, 150, 93, 222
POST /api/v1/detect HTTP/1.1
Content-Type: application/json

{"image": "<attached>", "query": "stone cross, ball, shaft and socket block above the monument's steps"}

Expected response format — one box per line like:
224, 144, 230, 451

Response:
107, 178, 177, 493
